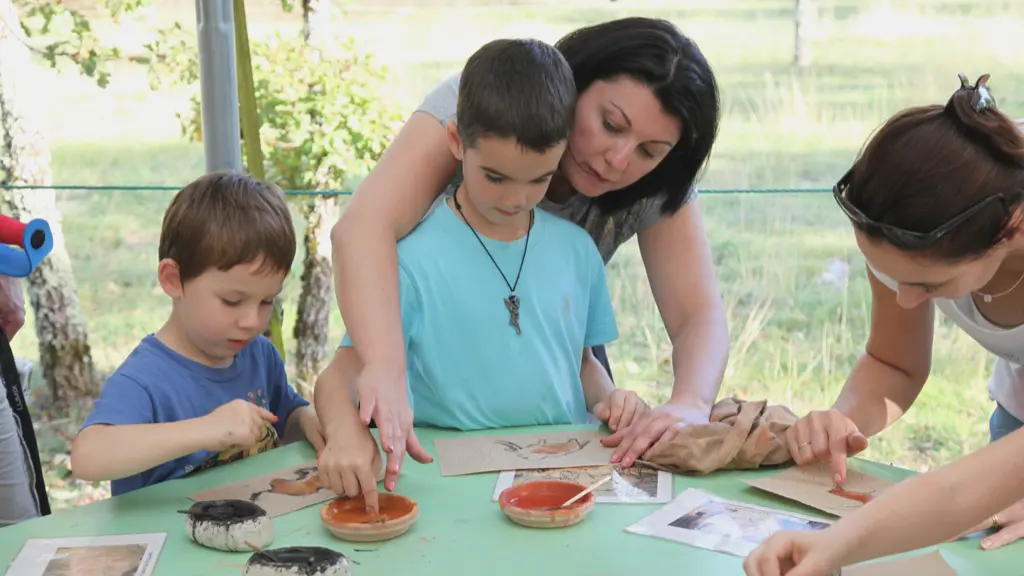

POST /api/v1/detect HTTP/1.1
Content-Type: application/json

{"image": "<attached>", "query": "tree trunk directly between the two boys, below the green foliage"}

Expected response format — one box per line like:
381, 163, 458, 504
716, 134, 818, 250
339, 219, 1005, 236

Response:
294, 196, 335, 398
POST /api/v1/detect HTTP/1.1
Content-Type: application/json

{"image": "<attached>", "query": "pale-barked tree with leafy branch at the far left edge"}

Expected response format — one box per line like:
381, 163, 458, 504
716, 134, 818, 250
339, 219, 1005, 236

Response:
0, 0, 132, 414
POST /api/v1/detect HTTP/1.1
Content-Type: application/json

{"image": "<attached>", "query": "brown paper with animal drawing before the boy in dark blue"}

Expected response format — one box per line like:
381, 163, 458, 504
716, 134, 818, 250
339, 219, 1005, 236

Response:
188, 460, 337, 518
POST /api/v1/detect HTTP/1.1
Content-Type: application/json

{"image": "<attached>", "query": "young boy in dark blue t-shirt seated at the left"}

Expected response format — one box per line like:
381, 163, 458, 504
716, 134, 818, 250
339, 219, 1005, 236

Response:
71, 173, 324, 495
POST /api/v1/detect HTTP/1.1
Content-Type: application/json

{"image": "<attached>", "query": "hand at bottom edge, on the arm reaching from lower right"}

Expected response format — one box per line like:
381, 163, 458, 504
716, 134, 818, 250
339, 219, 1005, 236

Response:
743, 530, 842, 576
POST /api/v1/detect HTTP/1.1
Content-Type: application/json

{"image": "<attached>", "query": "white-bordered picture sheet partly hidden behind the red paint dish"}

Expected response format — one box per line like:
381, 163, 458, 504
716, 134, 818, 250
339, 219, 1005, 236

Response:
490, 464, 672, 504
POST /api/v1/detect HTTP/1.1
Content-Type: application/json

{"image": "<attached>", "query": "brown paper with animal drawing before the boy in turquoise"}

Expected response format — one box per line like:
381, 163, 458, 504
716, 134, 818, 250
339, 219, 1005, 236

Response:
434, 430, 614, 476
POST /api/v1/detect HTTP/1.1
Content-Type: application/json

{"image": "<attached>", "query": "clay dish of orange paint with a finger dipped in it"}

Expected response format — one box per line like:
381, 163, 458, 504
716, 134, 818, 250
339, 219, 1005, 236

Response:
321, 492, 420, 542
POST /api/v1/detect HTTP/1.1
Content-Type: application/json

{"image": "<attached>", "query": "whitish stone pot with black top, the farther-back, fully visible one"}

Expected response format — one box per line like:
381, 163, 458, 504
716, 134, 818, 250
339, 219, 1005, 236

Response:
184, 500, 273, 552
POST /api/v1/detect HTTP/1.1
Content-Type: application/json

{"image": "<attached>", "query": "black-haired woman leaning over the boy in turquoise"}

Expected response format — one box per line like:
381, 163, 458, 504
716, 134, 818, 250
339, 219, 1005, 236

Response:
322, 17, 729, 489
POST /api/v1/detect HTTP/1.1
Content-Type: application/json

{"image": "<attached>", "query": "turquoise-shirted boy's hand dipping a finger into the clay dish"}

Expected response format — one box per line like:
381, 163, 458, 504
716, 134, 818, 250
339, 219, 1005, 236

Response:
316, 416, 384, 513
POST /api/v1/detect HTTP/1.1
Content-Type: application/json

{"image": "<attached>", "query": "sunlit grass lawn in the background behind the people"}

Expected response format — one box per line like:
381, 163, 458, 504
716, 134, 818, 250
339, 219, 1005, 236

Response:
15, 0, 1024, 508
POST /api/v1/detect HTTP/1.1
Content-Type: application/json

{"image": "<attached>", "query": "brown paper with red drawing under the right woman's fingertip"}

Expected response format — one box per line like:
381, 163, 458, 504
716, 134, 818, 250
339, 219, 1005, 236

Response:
744, 462, 893, 517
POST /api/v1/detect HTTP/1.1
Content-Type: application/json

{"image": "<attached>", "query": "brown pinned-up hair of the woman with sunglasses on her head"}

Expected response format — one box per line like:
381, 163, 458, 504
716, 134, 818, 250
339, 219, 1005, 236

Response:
846, 75, 1024, 261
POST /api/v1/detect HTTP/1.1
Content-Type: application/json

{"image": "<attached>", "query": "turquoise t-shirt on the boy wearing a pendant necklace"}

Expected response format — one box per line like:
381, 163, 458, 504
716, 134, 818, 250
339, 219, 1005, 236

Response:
342, 194, 618, 430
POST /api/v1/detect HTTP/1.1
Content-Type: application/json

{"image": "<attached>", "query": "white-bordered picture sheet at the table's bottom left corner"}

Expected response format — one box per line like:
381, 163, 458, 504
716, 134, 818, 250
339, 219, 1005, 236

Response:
7, 532, 167, 576
